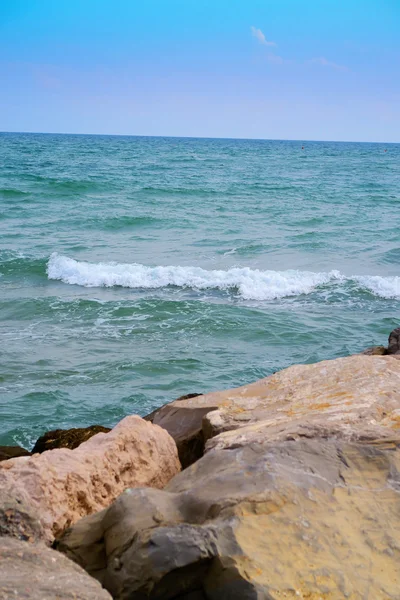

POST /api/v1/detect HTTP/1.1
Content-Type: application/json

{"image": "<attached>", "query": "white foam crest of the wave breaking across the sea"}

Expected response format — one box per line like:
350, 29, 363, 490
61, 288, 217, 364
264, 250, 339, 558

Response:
47, 253, 400, 300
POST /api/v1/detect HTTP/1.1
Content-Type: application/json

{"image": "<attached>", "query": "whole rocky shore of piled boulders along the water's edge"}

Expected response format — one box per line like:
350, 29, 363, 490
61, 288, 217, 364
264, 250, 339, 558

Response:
0, 329, 400, 600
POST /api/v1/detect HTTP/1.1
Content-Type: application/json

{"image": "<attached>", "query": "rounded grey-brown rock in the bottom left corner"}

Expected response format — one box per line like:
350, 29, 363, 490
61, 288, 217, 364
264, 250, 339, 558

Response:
0, 538, 111, 600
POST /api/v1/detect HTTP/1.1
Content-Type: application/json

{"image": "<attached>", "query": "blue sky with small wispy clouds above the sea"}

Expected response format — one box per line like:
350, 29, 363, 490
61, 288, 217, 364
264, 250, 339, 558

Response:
0, 0, 400, 142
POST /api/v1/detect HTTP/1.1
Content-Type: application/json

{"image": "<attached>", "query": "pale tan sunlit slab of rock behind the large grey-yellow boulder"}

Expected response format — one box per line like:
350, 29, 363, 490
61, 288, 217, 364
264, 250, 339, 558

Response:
203, 355, 400, 449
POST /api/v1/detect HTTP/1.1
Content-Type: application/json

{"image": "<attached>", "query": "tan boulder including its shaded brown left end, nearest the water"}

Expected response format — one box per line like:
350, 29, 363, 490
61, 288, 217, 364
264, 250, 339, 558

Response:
145, 355, 400, 467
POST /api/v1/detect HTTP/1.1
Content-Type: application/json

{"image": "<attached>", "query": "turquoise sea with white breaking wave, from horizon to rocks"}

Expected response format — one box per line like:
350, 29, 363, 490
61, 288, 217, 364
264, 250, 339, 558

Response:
0, 134, 400, 448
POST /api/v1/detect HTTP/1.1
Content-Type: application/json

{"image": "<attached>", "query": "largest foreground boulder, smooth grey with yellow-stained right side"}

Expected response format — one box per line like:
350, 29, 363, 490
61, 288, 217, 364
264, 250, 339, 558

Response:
58, 438, 400, 600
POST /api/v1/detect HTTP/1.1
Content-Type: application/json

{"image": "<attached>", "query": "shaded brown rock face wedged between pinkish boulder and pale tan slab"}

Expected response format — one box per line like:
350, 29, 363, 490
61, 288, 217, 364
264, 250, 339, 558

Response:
144, 394, 203, 469
